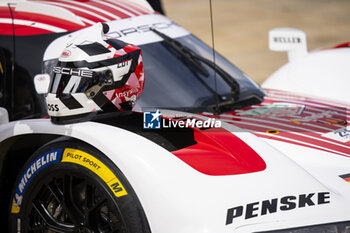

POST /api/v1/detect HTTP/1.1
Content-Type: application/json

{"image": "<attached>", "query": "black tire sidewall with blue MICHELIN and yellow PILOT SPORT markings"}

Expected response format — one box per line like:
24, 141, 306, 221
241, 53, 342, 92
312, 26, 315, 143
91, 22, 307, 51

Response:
9, 139, 150, 233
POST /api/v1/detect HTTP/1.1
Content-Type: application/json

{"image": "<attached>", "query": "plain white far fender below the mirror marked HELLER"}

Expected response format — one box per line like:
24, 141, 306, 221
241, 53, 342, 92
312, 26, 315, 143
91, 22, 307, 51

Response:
262, 44, 350, 106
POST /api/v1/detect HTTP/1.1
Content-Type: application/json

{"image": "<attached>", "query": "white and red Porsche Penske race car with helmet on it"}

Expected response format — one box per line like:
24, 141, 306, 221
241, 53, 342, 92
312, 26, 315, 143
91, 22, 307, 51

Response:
0, 0, 350, 233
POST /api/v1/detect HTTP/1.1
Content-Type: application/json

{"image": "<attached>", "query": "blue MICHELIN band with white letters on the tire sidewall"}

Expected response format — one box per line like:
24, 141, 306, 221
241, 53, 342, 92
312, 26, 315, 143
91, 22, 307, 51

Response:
11, 149, 62, 214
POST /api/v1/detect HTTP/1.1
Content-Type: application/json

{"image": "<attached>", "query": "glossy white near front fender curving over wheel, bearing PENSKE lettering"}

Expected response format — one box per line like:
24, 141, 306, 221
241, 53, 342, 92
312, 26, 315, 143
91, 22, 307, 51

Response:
0, 116, 350, 233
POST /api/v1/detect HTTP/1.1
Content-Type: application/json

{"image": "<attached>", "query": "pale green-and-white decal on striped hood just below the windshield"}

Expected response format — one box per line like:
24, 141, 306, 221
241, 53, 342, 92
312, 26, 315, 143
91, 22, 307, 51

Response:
237, 102, 305, 117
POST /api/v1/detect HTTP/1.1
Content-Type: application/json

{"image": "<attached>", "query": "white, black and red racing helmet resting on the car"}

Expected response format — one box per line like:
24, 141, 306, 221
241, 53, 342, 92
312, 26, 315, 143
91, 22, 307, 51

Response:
46, 23, 144, 123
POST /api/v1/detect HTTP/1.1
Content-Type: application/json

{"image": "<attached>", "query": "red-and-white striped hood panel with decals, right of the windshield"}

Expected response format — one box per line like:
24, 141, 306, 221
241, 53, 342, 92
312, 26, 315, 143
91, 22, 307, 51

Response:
212, 90, 350, 157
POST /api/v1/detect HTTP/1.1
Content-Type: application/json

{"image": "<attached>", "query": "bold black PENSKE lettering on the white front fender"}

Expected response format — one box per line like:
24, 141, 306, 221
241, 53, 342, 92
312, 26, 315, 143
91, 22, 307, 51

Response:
226, 192, 331, 225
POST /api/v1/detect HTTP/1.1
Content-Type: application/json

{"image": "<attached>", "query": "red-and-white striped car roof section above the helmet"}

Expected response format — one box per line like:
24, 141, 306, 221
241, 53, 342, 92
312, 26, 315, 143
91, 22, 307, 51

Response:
0, 0, 154, 36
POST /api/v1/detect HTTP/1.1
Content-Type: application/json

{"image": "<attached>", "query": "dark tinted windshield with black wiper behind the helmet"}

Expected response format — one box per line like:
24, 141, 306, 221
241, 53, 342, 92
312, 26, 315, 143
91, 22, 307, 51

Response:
44, 35, 264, 112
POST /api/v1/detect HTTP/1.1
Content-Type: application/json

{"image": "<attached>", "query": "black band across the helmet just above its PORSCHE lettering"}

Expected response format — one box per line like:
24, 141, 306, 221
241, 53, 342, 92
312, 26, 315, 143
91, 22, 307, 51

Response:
57, 49, 141, 69
